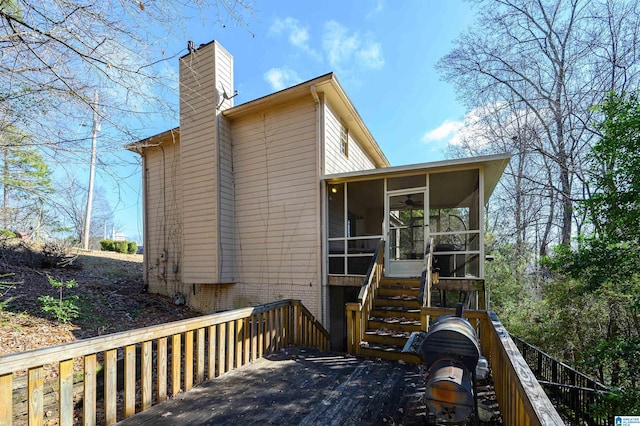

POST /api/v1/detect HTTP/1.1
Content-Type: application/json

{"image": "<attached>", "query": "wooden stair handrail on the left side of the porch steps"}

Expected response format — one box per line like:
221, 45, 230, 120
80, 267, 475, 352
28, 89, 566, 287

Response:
346, 240, 384, 354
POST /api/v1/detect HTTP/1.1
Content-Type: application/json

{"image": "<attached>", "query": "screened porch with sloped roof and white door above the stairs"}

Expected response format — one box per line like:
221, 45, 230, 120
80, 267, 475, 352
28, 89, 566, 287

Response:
323, 154, 510, 307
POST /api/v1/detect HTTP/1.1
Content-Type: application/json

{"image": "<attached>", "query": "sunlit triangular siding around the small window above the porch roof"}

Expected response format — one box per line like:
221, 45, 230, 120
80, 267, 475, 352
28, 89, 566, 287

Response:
324, 100, 375, 174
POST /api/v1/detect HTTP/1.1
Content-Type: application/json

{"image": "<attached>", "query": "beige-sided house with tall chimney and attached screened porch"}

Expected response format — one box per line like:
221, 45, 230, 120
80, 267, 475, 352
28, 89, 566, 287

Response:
127, 41, 509, 346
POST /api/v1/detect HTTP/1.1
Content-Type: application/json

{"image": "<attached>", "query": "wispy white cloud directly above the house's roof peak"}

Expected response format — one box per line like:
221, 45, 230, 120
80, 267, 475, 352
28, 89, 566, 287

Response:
322, 21, 384, 71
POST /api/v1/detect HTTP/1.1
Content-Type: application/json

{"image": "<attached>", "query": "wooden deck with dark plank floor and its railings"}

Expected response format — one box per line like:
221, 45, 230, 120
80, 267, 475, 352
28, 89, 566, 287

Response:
0, 300, 563, 426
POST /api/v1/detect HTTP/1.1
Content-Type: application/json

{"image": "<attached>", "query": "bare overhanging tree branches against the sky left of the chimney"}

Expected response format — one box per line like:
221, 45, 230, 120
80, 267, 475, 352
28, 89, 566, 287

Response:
0, 0, 252, 241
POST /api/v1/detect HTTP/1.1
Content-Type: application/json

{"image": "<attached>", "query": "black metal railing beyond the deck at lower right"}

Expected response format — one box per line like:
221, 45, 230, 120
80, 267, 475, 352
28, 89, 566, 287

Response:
511, 336, 613, 426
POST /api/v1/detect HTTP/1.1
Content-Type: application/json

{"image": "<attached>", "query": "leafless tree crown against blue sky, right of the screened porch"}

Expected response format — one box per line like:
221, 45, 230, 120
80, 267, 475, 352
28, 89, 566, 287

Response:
438, 0, 640, 254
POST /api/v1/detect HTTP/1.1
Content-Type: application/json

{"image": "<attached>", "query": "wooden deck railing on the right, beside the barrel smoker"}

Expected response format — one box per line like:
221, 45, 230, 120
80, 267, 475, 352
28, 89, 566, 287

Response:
421, 307, 564, 425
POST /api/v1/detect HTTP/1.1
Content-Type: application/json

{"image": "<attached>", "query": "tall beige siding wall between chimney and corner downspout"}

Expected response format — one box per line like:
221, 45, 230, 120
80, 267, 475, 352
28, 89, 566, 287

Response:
231, 97, 320, 315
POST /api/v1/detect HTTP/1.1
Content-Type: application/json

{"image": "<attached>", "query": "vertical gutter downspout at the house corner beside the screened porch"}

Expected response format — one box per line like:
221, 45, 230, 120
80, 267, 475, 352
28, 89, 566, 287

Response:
310, 84, 329, 329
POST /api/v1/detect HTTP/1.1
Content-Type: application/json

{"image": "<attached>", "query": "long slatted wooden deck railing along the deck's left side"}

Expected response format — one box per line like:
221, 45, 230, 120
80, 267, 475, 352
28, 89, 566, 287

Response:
0, 300, 329, 426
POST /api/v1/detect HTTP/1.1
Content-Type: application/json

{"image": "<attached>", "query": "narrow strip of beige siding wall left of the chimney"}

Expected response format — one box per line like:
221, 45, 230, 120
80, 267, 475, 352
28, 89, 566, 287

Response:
144, 140, 182, 296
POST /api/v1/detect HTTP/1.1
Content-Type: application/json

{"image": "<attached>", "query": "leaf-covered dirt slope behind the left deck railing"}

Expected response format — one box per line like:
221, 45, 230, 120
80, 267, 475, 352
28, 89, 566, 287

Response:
0, 245, 200, 355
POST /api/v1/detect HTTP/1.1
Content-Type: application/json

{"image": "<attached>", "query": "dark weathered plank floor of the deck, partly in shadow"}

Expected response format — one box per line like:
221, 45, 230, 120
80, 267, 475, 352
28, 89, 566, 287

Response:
118, 347, 424, 426
